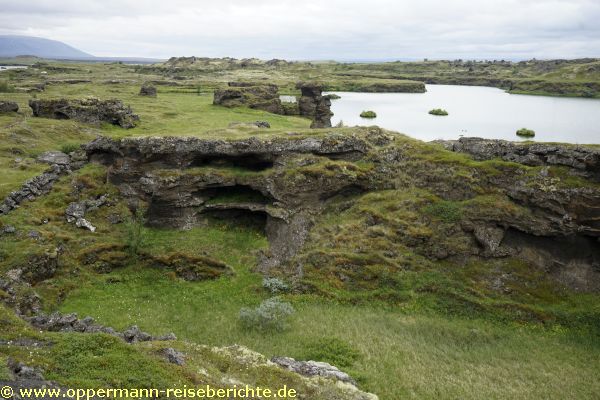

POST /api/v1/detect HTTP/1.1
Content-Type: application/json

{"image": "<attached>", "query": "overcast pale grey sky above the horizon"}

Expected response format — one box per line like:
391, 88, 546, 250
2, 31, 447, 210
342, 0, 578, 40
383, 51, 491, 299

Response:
0, 0, 600, 60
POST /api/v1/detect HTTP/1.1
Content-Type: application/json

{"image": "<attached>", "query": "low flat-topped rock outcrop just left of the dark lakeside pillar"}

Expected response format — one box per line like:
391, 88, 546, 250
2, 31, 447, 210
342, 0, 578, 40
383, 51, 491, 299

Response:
213, 82, 283, 114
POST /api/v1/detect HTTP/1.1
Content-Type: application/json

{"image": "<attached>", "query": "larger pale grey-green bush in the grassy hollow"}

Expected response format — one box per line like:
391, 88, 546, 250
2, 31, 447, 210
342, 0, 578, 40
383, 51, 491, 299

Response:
239, 297, 294, 331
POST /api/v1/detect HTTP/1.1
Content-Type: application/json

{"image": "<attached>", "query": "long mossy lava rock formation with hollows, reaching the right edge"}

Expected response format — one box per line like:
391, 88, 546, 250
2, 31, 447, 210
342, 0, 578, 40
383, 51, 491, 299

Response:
86, 128, 600, 291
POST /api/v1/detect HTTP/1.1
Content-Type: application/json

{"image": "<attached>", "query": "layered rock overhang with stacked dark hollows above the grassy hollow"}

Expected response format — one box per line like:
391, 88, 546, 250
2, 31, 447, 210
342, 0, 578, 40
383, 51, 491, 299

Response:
86, 134, 371, 265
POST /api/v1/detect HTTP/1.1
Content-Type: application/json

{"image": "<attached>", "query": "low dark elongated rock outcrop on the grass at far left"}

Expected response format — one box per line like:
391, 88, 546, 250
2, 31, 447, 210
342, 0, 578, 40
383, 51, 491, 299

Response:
29, 98, 140, 129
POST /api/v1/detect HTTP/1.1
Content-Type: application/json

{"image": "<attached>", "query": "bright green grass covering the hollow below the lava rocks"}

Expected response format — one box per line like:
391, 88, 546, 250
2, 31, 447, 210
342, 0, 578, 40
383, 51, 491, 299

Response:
55, 227, 600, 400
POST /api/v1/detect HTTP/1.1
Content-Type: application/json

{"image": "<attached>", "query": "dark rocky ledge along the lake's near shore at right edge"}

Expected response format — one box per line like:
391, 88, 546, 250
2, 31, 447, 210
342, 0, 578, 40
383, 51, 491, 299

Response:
436, 137, 600, 181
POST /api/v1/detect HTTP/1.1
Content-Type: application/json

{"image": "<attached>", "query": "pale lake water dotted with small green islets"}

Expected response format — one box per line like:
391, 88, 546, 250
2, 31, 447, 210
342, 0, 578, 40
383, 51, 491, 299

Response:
331, 85, 600, 144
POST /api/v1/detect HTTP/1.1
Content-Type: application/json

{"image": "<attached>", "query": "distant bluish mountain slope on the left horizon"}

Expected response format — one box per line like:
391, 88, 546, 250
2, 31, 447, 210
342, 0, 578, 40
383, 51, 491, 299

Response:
0, 35, 95, 60
